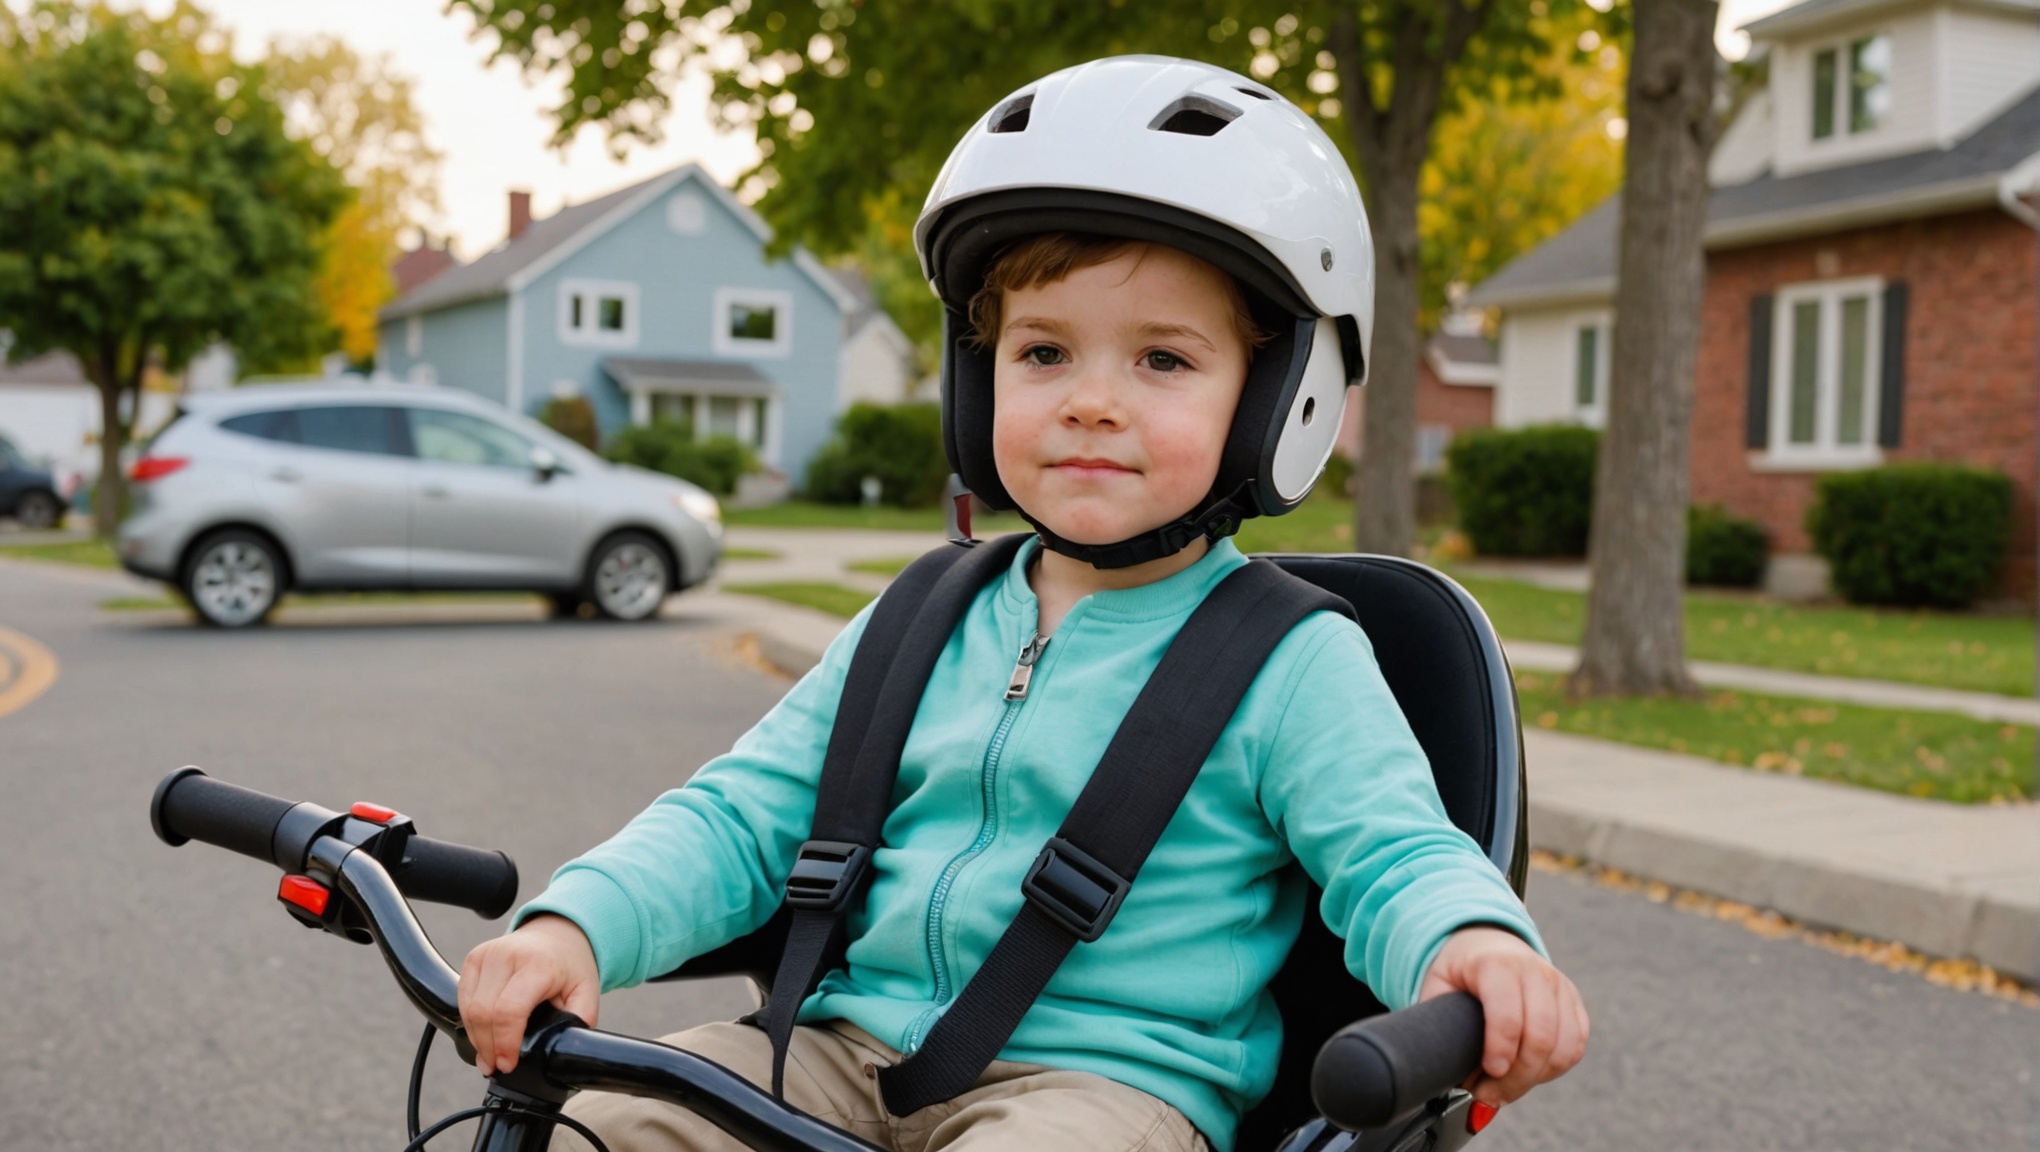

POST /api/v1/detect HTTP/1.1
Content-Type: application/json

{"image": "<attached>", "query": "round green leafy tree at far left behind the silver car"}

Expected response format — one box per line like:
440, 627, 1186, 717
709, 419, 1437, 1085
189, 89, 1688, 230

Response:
0, 2, 347, 534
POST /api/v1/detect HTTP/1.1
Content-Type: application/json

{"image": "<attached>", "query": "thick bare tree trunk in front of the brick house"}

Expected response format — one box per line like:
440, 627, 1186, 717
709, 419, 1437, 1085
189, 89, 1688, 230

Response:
1571, 0, 1716, 695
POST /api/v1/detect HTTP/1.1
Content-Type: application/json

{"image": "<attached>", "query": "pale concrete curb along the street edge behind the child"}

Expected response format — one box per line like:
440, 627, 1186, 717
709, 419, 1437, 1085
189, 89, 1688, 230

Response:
726, 593, 2040, 983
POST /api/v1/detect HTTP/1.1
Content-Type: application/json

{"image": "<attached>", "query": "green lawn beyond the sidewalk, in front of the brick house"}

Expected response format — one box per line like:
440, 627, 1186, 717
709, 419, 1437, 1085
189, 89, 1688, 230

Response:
1459, 575, 2034, 695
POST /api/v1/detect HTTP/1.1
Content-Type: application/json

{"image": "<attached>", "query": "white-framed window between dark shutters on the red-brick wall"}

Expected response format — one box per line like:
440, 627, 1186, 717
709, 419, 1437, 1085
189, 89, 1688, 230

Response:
1752, 275, 1885, 471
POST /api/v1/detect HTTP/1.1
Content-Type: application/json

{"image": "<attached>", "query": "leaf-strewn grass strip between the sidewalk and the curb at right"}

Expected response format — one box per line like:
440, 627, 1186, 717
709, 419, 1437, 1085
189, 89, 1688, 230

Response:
1516, 673, 2034, 803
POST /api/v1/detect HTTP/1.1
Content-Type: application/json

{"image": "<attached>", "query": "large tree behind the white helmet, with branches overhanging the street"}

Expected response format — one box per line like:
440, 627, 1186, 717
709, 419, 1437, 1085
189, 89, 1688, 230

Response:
449, 0, 1610, 553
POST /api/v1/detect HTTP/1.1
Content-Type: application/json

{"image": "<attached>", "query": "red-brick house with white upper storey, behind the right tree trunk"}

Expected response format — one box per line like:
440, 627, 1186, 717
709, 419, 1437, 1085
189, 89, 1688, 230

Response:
1469, 0, 2040, 597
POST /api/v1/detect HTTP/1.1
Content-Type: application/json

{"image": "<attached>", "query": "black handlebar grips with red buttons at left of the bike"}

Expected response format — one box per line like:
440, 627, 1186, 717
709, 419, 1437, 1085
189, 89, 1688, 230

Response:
149, 767, 518, 920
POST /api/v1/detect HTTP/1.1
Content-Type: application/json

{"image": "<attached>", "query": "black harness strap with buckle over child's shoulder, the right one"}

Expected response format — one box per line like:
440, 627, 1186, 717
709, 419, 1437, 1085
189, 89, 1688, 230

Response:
879, 561, 1353, 1115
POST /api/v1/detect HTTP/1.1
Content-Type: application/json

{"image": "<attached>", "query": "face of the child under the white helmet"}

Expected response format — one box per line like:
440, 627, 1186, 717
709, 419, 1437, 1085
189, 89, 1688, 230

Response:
991, 245, 1248, 544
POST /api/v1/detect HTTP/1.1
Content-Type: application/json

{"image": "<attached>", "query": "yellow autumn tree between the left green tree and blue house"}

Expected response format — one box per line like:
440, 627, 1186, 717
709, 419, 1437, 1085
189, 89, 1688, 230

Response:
263, 37, 443, 365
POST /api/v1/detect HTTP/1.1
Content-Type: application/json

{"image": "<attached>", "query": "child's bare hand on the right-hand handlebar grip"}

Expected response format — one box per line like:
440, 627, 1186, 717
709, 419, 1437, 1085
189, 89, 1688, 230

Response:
1418, 928, 1587, 1107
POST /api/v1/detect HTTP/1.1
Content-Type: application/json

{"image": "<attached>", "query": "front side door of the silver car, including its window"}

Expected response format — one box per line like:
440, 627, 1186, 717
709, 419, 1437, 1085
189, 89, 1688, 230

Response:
406, 408, 581, 587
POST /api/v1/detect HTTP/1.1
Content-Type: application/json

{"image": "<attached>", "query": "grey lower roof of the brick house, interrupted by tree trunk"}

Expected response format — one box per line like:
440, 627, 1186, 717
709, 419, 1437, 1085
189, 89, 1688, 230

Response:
1467, 84, 2040, 308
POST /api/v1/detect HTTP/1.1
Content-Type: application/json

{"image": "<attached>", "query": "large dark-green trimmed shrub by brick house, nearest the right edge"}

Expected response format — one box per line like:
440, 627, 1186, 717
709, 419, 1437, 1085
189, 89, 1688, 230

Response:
1805, 463, 2011, 608
